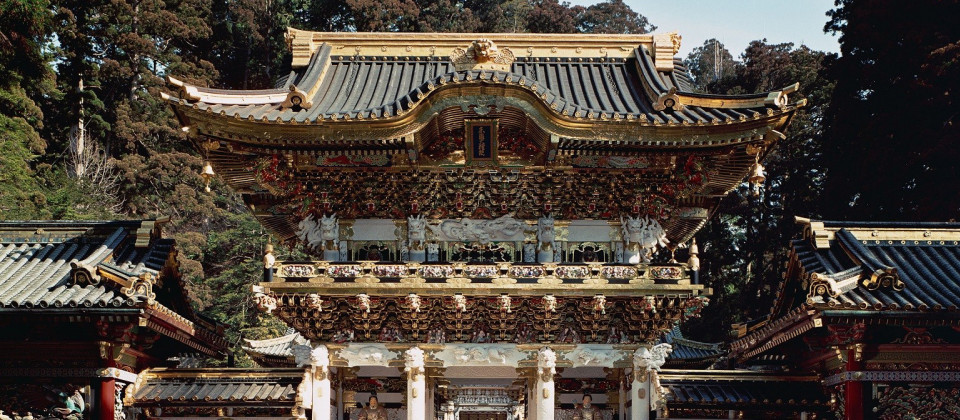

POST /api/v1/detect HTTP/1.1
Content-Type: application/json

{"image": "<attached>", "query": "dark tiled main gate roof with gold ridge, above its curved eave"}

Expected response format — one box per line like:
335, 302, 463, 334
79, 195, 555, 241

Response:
167, 29, 798, 131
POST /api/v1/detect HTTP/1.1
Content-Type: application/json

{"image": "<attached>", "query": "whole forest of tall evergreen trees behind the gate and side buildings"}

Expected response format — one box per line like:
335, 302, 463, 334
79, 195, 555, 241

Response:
0, 0, 960, 363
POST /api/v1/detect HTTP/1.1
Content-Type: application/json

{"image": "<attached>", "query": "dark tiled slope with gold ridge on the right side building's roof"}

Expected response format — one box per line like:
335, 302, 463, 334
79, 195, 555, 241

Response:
792, 221, 960, 311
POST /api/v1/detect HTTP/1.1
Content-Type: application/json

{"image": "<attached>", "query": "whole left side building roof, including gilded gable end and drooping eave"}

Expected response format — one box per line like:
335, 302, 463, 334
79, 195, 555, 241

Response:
0, 219, 226, 355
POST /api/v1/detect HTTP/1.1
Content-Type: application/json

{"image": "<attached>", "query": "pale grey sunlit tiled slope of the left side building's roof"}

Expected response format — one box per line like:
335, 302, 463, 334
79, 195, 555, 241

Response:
0, 220, 167, 309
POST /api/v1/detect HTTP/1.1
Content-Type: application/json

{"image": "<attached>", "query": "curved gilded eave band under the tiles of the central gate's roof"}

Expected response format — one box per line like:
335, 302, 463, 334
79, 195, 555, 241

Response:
167, 84, 802, 147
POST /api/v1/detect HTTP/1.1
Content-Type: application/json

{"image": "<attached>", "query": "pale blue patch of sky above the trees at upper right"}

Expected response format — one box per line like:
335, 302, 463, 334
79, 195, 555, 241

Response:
571, 0, 840, 57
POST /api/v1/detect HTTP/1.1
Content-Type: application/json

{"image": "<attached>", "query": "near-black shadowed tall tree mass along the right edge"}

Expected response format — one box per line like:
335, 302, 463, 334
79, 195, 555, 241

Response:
824, 0, 960, 221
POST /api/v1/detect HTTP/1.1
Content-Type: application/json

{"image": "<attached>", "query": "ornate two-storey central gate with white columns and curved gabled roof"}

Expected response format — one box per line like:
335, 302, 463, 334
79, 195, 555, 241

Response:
158, 29, 804, 420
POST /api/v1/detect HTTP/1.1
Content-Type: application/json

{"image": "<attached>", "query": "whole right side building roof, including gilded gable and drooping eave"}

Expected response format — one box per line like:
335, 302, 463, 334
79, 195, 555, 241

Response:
730, 218, 960, 358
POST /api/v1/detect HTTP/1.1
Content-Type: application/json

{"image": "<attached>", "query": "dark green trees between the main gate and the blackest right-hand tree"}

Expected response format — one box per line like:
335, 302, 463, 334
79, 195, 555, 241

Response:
685, 41, 833, 341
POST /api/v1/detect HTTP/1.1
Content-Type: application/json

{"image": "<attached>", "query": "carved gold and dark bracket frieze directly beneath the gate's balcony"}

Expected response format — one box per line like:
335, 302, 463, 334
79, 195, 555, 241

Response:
273, 294, 689, 344
